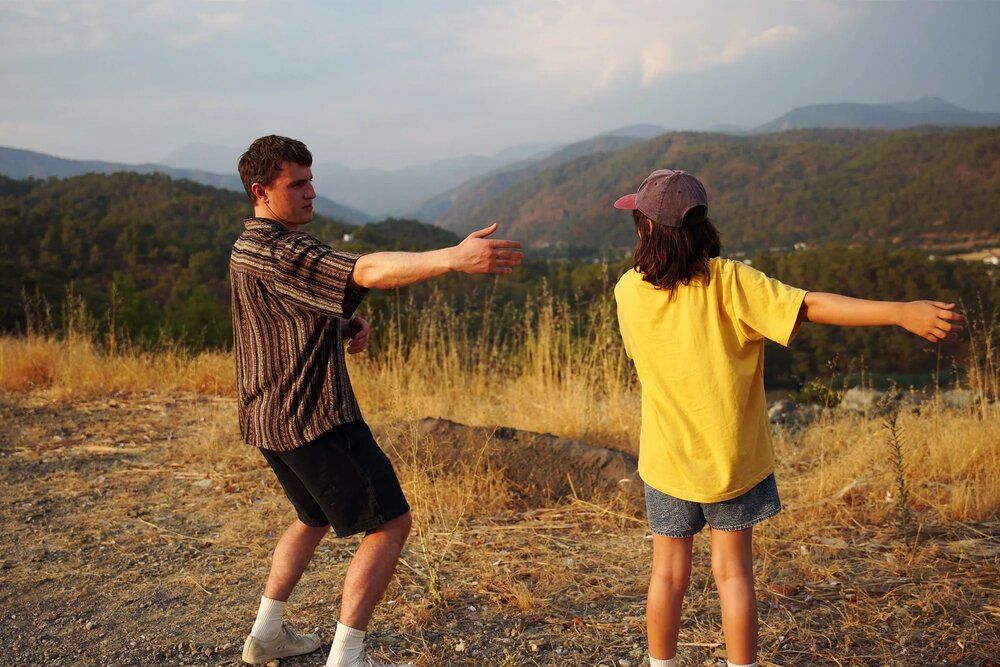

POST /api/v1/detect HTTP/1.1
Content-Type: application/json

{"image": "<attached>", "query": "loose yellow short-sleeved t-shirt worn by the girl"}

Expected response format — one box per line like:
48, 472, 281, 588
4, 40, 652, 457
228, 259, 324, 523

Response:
615, 258, 806, 503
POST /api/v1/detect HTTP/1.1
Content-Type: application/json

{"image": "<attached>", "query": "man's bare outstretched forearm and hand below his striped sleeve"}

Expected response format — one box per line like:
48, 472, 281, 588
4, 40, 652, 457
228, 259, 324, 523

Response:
351, 223, 524, 289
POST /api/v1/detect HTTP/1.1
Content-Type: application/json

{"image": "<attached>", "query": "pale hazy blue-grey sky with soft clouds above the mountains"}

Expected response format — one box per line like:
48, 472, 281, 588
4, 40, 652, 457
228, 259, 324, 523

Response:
0, 0, 1000, 168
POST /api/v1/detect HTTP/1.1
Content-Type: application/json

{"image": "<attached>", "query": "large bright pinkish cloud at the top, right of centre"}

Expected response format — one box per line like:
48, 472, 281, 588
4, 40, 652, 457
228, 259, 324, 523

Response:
437, 0, 852, 95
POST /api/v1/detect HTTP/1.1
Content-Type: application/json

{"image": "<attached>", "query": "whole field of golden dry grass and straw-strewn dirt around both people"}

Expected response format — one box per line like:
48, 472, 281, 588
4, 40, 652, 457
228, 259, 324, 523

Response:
0, 303, 1000, 666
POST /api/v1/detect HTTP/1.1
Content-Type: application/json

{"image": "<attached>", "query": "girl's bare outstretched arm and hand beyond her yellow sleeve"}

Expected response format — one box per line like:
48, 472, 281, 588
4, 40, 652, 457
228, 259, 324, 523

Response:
799, 292, 965, 343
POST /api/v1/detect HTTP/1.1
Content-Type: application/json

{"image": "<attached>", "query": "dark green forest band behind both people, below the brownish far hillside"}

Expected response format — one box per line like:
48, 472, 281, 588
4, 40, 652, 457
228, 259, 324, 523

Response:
0, 173, 1000, 386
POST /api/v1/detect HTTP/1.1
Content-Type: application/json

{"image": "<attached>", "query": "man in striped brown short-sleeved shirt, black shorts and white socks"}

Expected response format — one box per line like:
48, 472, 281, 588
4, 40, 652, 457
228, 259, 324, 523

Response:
230, 135, 523, 667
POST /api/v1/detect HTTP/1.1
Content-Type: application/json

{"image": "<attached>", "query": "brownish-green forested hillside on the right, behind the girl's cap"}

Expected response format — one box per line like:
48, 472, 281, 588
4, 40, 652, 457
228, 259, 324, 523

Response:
451, 128, 1000, 254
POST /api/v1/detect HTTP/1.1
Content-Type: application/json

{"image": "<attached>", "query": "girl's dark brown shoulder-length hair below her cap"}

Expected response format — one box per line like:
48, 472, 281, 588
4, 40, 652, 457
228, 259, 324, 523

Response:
632, 206, 722, 290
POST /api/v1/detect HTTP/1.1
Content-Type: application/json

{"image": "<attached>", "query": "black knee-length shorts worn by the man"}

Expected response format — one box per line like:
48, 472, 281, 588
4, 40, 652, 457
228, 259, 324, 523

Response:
260, 419, 410, 537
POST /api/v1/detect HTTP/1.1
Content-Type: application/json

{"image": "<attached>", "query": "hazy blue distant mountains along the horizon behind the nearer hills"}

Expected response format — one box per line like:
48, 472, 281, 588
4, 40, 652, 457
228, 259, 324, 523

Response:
0, 97, 1000, 230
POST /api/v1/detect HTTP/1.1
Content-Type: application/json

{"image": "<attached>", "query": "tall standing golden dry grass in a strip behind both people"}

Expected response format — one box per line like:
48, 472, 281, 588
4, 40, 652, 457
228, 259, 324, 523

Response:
0, 298, 1000, 520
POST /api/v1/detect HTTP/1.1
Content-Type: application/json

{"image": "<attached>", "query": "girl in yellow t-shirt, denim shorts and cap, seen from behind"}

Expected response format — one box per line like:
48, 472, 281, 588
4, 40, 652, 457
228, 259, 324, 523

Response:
615, 169, 964, 667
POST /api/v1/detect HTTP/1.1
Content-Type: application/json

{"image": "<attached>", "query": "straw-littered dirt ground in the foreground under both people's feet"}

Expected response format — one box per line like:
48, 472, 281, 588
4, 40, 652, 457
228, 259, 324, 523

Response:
0, 394, 1000, 667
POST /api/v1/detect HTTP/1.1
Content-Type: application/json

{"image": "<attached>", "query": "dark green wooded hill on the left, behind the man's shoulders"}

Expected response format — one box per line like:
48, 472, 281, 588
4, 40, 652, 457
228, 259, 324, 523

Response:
0, 172, 457, 346
